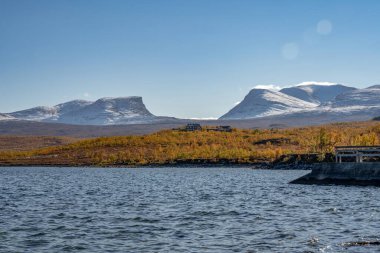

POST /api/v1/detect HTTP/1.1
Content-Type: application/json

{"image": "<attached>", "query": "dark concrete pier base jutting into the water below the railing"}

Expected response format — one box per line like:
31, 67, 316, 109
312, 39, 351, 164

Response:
290, 162, 380, 186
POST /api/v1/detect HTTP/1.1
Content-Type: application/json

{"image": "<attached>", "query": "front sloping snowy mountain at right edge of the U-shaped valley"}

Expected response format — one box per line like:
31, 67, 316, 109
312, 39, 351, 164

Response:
221, 89, 317, 119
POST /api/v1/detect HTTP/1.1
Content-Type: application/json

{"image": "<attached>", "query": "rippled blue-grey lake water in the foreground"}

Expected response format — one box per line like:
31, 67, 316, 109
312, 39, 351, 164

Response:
0, 168, 380, 252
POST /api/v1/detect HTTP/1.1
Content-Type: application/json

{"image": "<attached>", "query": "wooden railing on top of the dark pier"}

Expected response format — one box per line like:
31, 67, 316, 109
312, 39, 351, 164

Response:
335, 146, 380, 163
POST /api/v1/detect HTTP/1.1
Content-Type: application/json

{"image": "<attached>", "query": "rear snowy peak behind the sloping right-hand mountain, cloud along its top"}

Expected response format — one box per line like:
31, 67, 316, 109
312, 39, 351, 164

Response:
280, 83, 356, 105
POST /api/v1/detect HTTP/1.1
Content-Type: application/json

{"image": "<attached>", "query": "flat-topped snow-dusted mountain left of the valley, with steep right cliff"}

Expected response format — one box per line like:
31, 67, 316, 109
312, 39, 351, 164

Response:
4, 97, 164, 125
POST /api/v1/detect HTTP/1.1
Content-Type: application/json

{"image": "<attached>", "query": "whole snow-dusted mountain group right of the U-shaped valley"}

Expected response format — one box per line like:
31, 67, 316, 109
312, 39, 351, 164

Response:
220, 83, 380, 121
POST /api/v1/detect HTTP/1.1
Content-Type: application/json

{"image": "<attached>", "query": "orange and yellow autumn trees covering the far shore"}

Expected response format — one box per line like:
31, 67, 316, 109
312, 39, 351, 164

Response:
0, 121, 380, 166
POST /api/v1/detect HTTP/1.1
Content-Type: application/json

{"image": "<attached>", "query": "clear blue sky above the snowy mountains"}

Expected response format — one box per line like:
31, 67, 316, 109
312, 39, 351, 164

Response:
0, 0, 380, 118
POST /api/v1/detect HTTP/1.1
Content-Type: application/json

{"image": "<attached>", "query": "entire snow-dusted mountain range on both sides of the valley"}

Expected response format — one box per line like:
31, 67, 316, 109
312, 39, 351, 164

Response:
0, 83, 380, 127
